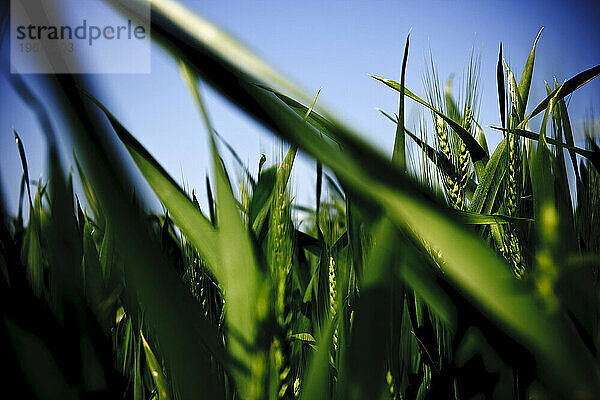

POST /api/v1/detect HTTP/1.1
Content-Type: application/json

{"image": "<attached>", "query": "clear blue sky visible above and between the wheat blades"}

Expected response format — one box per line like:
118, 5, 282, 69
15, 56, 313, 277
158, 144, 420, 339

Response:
0, 0, 600, 216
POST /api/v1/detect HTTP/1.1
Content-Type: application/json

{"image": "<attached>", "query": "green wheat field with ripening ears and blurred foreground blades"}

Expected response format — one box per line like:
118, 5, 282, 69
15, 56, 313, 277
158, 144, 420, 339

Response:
0, 0, 600, 400
